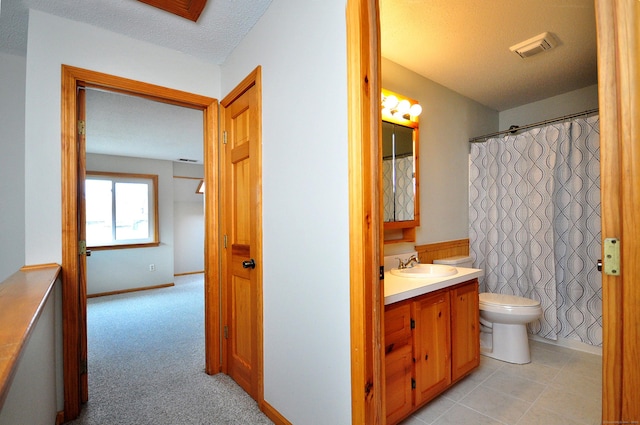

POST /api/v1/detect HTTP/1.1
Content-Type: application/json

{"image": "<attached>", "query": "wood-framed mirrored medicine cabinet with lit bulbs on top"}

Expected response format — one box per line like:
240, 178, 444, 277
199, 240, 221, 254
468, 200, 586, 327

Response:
382, 90, 420, 243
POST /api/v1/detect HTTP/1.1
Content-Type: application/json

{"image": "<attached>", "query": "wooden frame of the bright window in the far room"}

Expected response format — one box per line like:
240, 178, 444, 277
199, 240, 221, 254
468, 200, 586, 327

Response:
84, 171, 160, 251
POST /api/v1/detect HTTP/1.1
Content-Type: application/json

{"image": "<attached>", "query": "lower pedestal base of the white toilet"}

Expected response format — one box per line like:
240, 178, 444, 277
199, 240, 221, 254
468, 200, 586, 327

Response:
480, 323, 531, 364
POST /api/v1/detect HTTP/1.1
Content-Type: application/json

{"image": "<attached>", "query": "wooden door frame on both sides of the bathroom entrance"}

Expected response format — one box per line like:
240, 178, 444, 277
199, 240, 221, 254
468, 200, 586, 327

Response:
346, 0, 640, 424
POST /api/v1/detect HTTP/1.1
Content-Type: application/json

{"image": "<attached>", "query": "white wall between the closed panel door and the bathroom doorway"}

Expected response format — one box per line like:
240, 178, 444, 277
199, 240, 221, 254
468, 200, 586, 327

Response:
222, 0, 351, 424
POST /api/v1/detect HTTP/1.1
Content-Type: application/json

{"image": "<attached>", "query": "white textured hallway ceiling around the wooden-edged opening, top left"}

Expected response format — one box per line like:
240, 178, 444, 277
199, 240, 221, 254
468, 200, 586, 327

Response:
0, 0, 271, 64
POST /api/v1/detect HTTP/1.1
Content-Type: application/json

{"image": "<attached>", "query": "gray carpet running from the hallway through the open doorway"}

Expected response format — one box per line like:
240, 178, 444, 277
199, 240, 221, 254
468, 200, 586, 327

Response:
70, 275, 272, 425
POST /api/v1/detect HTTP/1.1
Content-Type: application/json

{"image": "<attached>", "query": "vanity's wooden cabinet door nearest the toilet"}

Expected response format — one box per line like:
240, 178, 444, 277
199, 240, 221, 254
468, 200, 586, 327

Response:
451, 279, 480, 381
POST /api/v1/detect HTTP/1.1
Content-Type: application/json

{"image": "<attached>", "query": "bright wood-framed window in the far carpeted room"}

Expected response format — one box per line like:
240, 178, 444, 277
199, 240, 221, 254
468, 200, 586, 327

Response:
85, 172, 159, 249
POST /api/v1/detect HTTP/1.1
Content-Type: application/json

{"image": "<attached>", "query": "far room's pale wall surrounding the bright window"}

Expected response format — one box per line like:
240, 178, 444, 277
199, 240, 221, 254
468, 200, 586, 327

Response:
87, 154, 174, 295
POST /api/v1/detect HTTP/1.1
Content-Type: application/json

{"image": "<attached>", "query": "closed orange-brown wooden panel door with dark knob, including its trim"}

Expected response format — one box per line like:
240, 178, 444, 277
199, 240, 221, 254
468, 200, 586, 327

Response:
221, 69, 262, 402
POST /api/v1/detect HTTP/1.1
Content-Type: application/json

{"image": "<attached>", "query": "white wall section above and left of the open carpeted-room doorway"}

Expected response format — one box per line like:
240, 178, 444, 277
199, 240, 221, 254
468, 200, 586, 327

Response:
25, 10, 220, 264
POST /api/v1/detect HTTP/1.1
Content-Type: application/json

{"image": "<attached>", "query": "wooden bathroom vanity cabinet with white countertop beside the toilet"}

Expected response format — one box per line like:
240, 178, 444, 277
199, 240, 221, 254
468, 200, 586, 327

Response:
384, 267, 483, 424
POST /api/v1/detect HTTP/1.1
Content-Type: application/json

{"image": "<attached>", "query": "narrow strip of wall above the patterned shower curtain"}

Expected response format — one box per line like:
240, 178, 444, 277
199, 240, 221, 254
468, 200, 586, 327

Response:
500, 84, 598, 128
